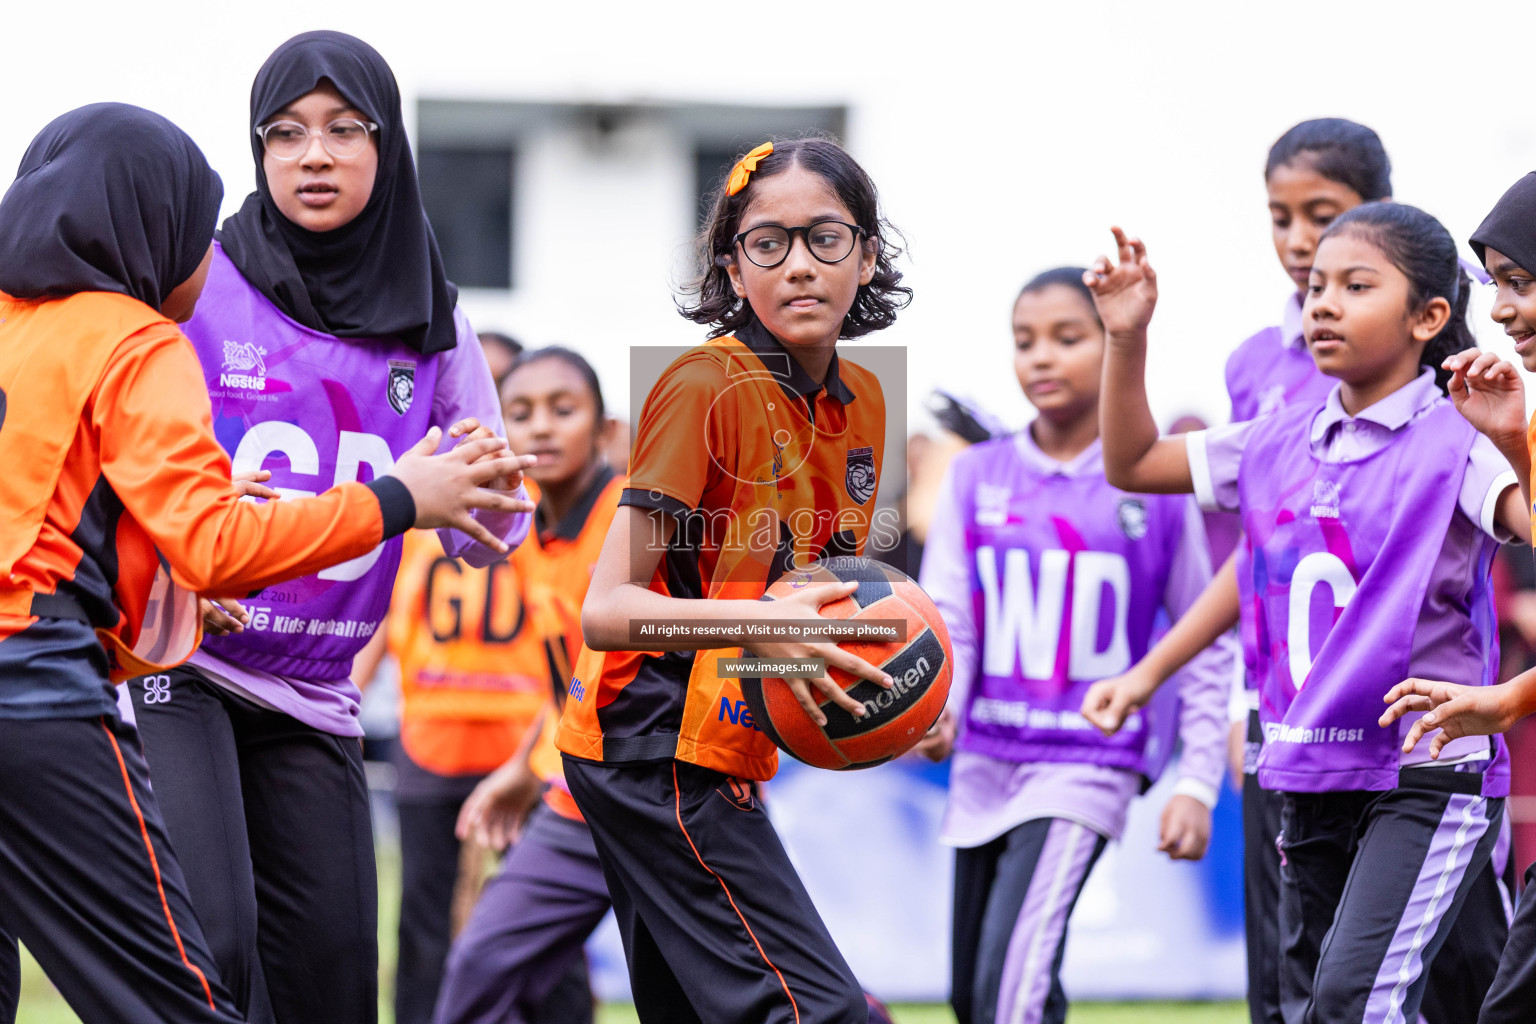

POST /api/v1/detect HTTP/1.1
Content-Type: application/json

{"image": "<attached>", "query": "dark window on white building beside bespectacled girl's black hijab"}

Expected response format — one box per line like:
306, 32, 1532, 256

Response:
416, 146, 513, 289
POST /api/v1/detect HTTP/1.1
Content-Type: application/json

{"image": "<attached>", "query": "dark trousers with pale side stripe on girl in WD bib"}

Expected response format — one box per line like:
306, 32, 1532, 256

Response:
949, 818, 1104, 1024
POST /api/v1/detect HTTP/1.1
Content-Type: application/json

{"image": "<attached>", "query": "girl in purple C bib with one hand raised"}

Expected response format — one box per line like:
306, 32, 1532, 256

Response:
1087, 203, 1530, 1022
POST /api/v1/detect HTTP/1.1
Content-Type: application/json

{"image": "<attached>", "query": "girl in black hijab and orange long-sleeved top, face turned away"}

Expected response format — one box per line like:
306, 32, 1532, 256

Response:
0, 103, 516, 1024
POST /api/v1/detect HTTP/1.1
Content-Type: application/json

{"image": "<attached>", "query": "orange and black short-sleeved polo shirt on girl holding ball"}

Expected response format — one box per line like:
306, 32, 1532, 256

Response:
556, 324, 885, 780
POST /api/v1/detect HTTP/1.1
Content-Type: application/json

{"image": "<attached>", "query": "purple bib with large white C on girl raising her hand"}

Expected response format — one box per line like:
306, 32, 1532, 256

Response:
1238, 399, 1495, 792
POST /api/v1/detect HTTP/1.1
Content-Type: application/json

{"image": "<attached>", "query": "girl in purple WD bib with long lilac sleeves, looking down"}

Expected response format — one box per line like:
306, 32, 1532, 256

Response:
922, 267, 1233, 1024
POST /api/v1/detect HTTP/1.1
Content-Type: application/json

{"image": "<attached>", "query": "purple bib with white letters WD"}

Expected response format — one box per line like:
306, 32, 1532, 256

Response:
952, 438, 1187, 777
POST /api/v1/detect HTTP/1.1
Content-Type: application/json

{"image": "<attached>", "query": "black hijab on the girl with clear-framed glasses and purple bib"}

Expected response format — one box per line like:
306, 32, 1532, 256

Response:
220, 32, 458, 355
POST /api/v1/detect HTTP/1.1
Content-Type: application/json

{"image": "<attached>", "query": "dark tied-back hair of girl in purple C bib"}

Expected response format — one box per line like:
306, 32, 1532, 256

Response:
1318, 203, 1478, 391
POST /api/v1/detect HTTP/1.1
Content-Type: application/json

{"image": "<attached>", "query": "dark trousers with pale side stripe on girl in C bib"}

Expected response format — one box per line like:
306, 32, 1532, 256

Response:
1279, 768, 1504, 1024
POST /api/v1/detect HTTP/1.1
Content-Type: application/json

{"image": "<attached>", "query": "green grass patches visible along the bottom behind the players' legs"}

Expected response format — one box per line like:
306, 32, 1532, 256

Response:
15, 854, 1247, 1024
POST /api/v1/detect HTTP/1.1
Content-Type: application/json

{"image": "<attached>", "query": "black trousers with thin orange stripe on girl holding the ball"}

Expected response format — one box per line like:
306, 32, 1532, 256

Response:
565, 757, 869, 1024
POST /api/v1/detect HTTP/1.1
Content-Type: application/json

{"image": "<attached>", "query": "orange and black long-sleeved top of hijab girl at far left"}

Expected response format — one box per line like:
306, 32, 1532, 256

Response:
0, 292, 396, 718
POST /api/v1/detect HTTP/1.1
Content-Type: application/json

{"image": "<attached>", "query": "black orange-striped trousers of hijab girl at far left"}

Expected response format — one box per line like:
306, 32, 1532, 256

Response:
0, 715, 244, 1024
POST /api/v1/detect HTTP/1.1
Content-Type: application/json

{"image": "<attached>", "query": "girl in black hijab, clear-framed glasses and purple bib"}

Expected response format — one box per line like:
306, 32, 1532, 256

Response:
129, 32, 531, 1024
